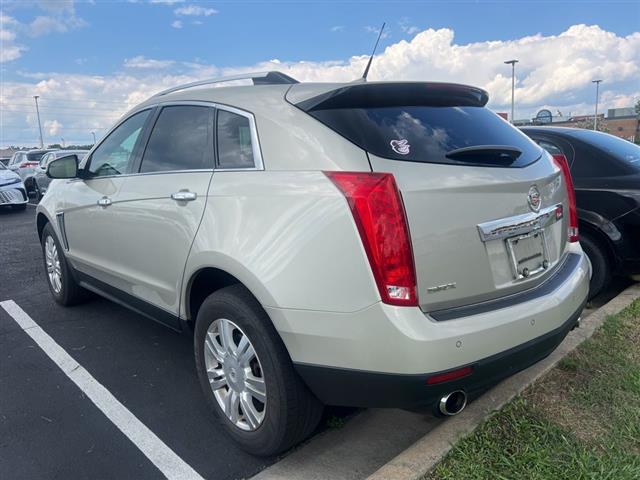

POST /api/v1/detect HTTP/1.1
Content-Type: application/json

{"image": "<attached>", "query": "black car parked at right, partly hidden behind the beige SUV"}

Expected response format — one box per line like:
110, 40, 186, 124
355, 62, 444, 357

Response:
522, 127, 640, 297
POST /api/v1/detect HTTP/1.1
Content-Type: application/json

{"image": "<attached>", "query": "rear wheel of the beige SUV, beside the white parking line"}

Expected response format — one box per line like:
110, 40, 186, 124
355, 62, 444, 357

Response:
194, 285, 323, 456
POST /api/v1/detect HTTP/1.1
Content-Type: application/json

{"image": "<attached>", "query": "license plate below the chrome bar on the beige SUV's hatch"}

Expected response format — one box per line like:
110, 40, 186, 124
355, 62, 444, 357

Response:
505, 229, 550, 279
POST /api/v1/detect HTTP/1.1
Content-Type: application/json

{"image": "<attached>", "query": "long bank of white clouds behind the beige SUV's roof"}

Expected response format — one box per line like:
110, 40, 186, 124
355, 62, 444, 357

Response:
0, 25, 640, 144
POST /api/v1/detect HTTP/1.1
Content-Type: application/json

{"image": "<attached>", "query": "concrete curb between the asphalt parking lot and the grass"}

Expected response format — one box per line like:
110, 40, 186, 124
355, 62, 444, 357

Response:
367, 284, 640, 480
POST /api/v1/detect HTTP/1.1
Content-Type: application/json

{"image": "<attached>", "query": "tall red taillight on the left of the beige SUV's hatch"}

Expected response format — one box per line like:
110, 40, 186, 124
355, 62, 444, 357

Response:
325, 172, 418, 306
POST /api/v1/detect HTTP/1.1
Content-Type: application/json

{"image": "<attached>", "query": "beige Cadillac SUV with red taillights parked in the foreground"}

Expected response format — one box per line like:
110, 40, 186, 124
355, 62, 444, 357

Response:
37, 72, 589, 455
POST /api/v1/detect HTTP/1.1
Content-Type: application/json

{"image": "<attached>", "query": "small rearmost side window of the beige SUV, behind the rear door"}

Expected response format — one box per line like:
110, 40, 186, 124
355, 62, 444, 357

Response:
217, 110, 255, 168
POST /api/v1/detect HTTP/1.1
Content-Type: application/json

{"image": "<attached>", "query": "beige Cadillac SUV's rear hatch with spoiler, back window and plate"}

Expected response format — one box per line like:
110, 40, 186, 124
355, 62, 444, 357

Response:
287, 82, 568, 311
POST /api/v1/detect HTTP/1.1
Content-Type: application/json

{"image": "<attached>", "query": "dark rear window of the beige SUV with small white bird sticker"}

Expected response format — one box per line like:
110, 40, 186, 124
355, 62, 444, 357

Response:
308, 106, 542, 167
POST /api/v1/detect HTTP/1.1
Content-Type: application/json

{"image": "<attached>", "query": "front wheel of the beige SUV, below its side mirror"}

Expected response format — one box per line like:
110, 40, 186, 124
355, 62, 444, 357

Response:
42, 223, 89, 306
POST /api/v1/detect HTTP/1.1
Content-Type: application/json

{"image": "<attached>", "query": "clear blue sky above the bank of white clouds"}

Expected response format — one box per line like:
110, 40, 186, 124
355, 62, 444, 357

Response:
5, 0, 640, 80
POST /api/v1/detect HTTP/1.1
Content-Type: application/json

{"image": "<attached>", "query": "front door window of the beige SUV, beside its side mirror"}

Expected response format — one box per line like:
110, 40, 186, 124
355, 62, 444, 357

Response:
88, 110, 151, 177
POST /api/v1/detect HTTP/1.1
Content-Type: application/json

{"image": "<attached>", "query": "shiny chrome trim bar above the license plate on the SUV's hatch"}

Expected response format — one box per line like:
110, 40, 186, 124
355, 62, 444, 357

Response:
478, 203, 564, 242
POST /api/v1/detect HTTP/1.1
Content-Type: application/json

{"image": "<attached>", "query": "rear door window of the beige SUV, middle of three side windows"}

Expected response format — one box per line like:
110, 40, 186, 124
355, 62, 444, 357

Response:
140, 105, 213, 173
